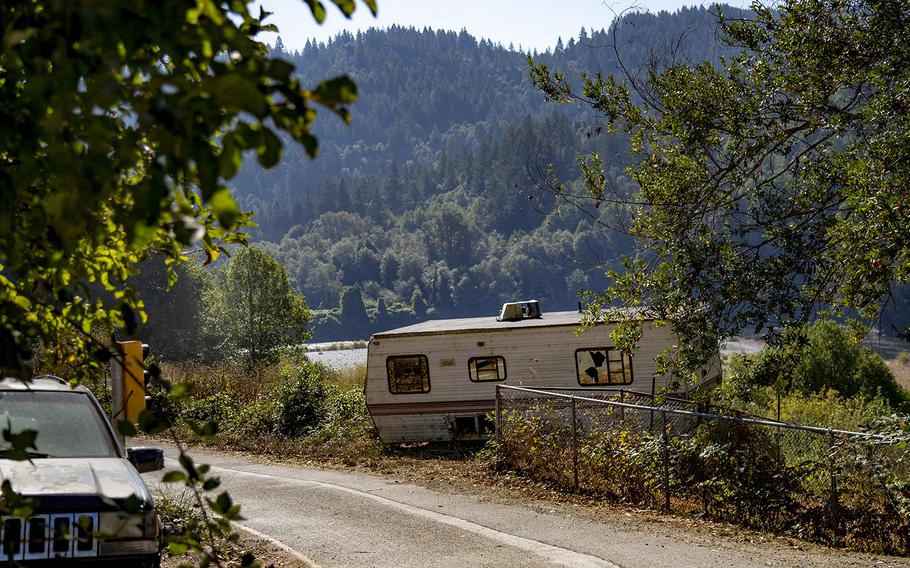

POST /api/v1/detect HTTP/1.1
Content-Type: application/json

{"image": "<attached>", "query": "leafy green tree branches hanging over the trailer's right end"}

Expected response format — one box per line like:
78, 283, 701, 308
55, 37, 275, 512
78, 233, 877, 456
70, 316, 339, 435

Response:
532, 0, 910, 376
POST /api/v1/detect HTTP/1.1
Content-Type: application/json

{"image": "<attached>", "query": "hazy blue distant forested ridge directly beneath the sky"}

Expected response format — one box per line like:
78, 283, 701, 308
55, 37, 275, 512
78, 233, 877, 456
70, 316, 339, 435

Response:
235, 8, 728, 203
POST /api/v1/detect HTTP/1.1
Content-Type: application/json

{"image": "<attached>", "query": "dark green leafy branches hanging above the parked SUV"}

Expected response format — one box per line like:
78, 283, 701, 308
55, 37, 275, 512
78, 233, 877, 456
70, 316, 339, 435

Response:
0, 0, 375, 377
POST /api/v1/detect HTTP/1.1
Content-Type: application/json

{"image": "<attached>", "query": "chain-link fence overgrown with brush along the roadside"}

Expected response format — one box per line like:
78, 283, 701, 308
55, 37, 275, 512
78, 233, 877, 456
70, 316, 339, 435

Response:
496, 385, 910, 555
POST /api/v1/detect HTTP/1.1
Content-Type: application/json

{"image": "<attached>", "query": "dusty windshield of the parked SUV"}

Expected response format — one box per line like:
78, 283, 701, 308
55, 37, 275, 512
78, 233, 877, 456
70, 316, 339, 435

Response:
0, 391, 117, 458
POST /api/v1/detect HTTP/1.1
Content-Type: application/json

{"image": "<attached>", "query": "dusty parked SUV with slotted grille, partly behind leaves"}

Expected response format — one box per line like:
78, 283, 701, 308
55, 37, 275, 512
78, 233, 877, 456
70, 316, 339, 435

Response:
0, 376, 164, 567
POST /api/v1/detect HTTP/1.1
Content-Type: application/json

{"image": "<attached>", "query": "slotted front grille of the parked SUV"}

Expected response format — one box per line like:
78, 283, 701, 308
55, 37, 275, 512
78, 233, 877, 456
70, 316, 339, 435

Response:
0, 513, 98, 561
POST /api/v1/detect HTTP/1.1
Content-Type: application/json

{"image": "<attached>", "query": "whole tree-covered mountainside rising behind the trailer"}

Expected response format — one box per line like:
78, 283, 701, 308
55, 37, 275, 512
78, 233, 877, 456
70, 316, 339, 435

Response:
221, 8, 910, 340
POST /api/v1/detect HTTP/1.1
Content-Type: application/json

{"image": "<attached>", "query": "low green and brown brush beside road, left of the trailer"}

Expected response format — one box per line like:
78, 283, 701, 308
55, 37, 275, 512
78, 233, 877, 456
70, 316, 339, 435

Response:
153, 352, 381, 465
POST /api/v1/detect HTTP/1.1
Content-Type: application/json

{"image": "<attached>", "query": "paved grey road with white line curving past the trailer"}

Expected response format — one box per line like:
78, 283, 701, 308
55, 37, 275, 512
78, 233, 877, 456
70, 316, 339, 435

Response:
146, 449, 910, 568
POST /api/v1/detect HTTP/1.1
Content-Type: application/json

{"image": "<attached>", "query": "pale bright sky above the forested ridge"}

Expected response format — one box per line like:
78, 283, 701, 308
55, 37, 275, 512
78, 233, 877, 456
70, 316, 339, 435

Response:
259, 0, 732, 51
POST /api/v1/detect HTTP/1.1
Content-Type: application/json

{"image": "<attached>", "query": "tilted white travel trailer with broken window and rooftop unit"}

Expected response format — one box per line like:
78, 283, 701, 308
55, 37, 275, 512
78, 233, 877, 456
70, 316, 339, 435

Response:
365, 301, 720, 443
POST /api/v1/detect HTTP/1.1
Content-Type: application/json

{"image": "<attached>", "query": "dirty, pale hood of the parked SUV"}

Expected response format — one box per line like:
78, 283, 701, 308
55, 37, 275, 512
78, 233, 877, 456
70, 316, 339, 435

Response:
0, 458, 152, 506
